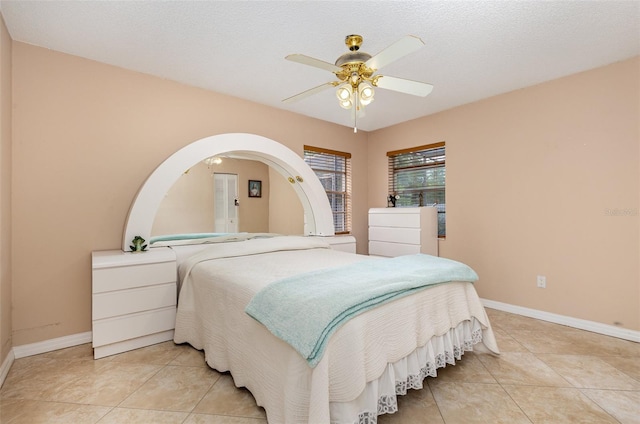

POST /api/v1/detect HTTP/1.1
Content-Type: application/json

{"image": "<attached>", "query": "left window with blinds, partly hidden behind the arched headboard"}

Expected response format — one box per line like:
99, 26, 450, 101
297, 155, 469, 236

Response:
304, 146, 351, 234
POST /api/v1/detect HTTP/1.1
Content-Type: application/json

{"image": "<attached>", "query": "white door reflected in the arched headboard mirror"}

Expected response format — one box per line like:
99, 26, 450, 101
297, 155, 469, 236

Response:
213, 173, 238, 233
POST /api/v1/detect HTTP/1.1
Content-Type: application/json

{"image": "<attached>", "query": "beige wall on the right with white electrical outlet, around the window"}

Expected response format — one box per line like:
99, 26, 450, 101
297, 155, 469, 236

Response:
368, 58, 640, 330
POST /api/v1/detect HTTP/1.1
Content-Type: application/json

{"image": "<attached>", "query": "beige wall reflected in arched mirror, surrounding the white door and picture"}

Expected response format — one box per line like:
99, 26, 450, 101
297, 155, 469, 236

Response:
151, 158, 272, 236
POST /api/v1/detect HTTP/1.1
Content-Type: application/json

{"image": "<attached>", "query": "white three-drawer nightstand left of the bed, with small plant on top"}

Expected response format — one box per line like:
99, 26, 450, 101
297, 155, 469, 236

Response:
91, 248, 177, 359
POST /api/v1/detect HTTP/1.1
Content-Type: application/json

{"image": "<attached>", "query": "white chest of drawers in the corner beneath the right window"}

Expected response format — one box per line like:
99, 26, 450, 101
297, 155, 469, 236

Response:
369, 207, 438, 257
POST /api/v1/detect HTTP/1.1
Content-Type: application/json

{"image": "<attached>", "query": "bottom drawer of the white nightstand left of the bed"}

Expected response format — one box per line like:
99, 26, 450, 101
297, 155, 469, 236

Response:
93, 306, 176, 347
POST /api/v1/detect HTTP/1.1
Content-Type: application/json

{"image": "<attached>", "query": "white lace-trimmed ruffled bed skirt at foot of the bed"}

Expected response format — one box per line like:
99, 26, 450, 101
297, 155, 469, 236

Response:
329, 318, 482, 424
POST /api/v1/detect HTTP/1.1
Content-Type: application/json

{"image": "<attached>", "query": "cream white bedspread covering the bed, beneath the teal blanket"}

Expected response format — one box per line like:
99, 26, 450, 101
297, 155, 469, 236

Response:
174, 237, 498, 424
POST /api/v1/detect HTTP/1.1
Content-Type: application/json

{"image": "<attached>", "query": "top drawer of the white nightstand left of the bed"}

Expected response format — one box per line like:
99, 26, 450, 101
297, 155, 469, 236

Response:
92, 261, 176, 293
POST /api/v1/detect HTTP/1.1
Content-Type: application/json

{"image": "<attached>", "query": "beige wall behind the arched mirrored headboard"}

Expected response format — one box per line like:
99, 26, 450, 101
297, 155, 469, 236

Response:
12, 42, 367, 346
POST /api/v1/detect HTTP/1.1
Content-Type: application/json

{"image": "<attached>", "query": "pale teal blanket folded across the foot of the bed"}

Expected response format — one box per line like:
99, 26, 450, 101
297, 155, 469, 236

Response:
245, 254, 478, 367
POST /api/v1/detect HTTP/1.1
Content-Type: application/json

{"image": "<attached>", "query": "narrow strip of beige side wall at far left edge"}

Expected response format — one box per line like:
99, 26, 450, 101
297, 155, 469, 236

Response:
0, 15, 12, 365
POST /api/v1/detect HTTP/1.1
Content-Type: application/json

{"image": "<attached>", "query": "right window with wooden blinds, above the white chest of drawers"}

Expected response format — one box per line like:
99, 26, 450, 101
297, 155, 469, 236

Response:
387, 142, 446, 237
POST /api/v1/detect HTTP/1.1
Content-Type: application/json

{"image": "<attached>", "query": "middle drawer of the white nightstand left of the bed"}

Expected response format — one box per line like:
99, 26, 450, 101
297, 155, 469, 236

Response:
92, 283, 177, 320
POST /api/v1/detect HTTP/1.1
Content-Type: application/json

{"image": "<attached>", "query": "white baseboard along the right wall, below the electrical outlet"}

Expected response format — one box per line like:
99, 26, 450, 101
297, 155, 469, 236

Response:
481, 299, 640, 343
